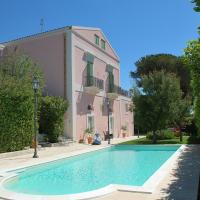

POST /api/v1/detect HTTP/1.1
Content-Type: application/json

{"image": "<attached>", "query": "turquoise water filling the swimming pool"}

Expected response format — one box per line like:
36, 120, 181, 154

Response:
4, 145, 180, 195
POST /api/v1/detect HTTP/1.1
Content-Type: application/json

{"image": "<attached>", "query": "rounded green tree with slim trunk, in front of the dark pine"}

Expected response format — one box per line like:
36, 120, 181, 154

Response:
133, 71, 182, 143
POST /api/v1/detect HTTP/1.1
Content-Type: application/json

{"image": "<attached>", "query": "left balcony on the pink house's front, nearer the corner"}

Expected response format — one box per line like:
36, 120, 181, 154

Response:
84, 76, 104, 95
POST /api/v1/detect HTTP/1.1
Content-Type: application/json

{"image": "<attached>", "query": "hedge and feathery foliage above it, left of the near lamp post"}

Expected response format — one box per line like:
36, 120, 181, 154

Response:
0, 54, 43, 152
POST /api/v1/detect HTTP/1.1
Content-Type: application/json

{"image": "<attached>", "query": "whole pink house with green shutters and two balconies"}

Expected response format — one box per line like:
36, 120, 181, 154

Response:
0, 26, 134, 140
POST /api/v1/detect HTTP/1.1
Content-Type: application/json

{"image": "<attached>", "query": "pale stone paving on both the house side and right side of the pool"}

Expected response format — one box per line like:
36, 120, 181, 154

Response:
0, 136, 200, 200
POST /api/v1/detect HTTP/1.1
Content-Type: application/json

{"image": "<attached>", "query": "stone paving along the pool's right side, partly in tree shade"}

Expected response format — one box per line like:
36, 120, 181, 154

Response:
96, 145, 200, 200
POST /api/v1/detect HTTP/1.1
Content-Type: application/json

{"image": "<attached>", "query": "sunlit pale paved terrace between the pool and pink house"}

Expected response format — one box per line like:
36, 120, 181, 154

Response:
0, 136, 137, 171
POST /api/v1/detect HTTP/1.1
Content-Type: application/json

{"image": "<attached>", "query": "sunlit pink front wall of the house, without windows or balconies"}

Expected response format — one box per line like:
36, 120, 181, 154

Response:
73, 27, 133, 140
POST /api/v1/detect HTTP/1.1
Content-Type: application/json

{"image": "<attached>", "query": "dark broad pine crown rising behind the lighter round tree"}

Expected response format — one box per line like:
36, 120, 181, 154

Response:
131, 54, 190, 97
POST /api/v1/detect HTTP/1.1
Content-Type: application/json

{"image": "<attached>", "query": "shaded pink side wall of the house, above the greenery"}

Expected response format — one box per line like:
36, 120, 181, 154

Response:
4, 33, 65, 97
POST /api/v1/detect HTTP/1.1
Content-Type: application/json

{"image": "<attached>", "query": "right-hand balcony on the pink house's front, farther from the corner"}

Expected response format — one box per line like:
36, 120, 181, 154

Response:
107, 84, 130, 99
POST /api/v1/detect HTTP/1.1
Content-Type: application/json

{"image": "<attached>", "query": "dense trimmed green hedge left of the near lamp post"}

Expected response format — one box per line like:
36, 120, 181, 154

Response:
0, 93, 34, 153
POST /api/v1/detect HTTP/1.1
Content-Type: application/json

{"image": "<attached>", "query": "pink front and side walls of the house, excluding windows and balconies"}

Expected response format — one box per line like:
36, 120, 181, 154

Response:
1, 28, 133, 140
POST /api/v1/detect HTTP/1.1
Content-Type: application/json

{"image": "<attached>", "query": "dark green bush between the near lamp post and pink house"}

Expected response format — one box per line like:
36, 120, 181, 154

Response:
39, 96, 68, 143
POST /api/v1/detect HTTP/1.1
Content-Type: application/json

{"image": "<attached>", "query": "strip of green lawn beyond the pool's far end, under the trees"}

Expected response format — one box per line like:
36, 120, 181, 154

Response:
120, 136, 200, 144
